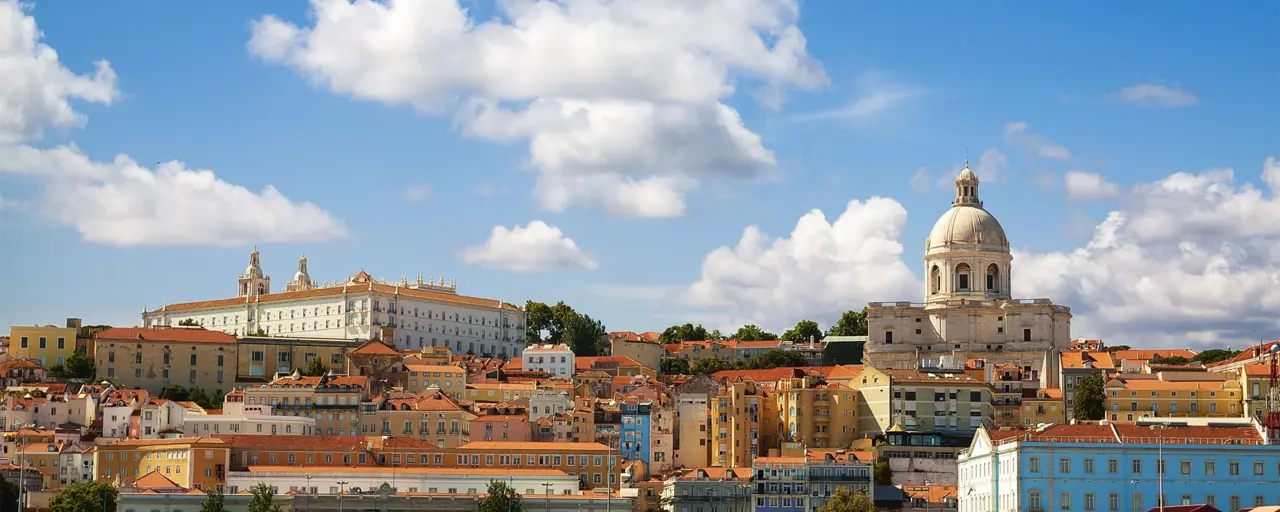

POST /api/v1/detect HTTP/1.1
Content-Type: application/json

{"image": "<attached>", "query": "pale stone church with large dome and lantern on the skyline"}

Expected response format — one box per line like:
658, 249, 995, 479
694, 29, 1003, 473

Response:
867, 161, 1071, 387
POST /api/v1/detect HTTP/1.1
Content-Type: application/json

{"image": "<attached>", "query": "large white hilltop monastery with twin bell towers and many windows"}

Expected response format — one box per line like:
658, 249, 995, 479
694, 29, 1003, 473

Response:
142, 248, 525, 356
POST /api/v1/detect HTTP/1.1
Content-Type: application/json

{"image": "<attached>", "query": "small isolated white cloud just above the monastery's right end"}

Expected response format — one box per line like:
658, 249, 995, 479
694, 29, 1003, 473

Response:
462, 220, 598, 273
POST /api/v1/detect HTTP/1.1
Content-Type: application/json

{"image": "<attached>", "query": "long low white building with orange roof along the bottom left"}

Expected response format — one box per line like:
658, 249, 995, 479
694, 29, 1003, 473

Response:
227, 466, 581, 503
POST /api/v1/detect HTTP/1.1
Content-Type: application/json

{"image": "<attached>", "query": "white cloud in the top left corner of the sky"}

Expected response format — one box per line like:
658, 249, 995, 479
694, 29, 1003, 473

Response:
0, 0, 119, 143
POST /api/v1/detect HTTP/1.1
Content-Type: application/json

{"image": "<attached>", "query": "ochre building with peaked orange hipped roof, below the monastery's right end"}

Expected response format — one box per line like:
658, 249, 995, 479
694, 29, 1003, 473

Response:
360, 389, 476, 448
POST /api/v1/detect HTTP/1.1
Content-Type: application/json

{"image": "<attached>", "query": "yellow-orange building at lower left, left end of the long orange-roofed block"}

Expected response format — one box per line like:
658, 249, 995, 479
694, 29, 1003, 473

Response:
93, 438, 230, 490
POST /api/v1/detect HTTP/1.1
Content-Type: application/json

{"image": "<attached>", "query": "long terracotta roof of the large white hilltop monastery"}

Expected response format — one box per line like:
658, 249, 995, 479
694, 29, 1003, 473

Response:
148, 277, 521, 314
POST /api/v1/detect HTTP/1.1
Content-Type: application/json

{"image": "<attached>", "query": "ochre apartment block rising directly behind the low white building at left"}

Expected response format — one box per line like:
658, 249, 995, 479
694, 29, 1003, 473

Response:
244, 371, 369, 435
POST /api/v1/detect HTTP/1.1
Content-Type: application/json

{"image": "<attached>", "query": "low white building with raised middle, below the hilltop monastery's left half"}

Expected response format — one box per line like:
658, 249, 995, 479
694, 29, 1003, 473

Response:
184, 392, 316, 438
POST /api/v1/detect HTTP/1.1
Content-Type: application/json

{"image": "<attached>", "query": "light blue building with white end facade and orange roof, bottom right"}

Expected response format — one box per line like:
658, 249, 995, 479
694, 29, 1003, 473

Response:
956, 417, 1280, 512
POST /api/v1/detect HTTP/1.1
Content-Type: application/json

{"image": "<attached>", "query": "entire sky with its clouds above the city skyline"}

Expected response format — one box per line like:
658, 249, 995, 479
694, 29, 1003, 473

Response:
0, 0, 1280, 348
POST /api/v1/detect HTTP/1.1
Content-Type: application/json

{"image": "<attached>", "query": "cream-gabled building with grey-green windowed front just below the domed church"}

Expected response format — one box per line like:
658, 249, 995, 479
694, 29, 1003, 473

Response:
850, 366, 992, 436
